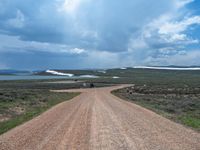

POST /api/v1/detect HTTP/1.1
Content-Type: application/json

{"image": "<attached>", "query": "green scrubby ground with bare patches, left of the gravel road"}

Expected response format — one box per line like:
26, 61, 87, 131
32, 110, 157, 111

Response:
0, 89, 79, 134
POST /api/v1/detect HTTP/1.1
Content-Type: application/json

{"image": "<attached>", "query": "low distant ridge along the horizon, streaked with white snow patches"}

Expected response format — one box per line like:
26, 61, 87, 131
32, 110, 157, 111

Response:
0, 65, 200, 77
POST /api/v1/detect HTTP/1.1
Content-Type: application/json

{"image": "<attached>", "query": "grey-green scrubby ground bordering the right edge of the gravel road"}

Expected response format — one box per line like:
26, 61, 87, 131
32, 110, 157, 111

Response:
113, 85, 200, 131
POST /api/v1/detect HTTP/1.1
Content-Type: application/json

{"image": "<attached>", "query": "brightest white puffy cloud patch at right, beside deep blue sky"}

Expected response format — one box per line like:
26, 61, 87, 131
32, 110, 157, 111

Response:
142, 15, 200, 44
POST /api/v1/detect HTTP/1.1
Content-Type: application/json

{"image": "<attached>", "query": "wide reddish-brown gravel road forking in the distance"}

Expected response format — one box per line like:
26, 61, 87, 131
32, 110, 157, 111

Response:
0, 86, 200, 150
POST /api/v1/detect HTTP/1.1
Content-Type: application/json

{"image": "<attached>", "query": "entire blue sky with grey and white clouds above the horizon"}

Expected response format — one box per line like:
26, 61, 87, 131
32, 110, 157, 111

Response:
0, 0, 200, 70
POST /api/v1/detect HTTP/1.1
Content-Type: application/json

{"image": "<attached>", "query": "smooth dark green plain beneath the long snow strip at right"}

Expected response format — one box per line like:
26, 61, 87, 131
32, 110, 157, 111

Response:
89, 68, 200, 87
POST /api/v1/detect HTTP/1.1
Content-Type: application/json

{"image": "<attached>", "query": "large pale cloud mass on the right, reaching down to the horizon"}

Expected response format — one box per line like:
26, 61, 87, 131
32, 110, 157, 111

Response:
125, 0, 200, 65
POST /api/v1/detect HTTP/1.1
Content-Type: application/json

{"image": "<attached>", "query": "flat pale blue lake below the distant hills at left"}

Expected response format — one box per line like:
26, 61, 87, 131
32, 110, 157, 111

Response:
0, 75, 74, 81
